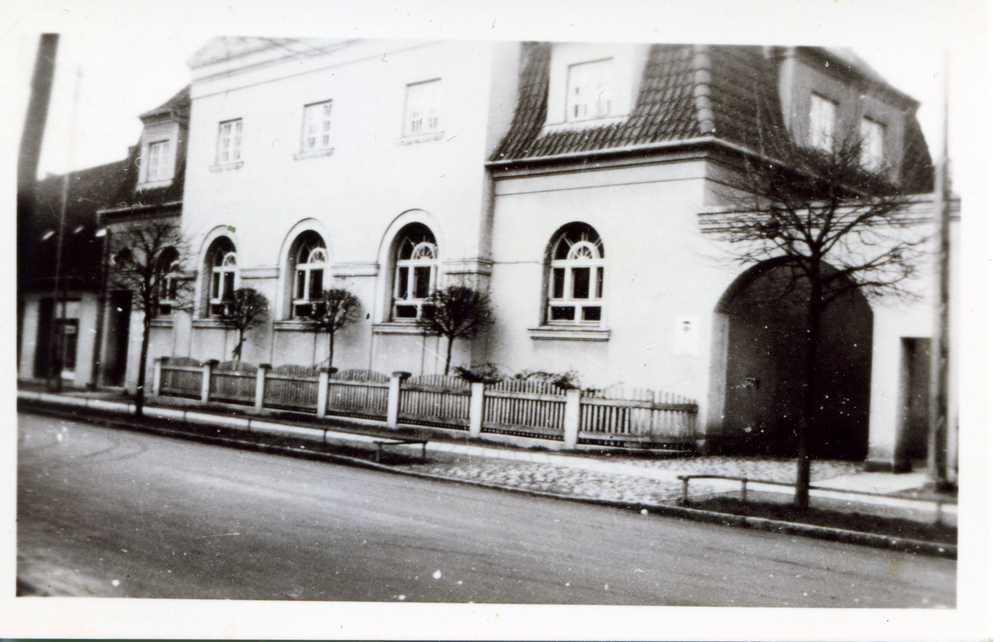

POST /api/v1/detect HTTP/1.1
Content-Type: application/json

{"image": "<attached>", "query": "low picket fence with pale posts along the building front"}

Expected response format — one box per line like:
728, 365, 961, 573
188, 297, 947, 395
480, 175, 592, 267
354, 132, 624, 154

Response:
153, 358, 698, 447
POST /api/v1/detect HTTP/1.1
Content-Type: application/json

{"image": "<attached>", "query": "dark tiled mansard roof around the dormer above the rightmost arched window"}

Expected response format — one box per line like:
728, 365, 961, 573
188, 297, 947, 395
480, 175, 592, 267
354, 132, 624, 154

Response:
491, 43, 784, 161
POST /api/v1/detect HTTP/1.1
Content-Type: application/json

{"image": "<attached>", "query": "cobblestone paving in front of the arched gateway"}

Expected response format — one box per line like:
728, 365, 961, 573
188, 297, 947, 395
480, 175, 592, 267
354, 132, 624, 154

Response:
407, 457, 859, 504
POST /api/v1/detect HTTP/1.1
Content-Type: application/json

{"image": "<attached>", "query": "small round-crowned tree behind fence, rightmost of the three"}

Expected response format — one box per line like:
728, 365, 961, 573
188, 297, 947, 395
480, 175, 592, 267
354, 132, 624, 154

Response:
418, 285, 493, 374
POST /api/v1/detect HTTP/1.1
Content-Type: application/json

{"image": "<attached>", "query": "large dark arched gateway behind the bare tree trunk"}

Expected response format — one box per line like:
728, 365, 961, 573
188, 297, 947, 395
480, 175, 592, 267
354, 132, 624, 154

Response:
708, 260, 872, 460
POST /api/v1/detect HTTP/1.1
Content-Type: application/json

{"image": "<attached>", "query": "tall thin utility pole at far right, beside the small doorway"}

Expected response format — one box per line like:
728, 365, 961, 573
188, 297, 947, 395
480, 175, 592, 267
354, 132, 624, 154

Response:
929, 52, 955, 491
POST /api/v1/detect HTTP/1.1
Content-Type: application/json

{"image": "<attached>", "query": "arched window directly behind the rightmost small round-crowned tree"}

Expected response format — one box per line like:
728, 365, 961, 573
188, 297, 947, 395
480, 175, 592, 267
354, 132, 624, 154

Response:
392, 223, 438, 321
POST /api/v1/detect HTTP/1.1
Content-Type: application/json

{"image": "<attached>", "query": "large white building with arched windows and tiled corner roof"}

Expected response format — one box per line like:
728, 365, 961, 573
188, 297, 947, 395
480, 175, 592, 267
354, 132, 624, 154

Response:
131, 39, 957, 469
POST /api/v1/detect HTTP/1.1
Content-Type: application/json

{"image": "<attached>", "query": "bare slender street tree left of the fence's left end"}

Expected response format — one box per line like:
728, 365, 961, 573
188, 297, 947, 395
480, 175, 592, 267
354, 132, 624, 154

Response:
109, 220, 191, 415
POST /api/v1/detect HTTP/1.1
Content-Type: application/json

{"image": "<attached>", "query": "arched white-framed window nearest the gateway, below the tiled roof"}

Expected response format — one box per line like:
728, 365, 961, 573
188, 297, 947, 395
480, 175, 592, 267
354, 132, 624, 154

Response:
546, 223, 604, 324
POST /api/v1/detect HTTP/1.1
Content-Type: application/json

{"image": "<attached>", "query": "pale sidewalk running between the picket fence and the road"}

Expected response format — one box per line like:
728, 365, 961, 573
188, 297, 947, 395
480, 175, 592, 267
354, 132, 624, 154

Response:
18, 386, 957, 556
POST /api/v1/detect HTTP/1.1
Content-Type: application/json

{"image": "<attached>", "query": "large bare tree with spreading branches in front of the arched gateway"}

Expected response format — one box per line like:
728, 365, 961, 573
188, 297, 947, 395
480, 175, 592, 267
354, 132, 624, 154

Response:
718, 142, 926, 508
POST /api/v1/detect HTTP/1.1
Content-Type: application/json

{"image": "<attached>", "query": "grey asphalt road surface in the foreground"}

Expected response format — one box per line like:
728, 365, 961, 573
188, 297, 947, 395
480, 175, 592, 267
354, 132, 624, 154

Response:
17, 414, 956, 608
